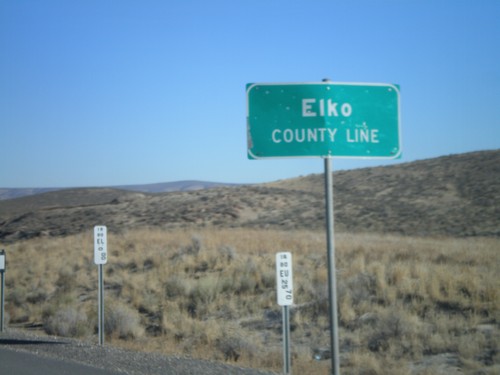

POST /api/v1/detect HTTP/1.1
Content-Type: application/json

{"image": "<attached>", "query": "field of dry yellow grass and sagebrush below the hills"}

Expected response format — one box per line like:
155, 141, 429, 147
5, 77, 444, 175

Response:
1, 229, 500, 374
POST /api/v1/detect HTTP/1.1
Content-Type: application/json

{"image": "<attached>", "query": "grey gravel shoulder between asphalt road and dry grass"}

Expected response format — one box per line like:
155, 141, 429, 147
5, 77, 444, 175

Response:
0, 328, 275, 375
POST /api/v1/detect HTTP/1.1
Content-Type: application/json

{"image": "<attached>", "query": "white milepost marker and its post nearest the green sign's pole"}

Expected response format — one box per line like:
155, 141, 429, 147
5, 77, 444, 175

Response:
276, 252, 293, 375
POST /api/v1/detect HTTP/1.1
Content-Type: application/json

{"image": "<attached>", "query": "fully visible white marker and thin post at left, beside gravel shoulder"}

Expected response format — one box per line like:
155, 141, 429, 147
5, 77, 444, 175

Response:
94, 225, 108, 345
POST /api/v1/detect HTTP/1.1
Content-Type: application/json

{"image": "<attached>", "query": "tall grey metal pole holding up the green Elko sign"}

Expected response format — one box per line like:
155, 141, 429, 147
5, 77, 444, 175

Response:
325, 158, 340, 375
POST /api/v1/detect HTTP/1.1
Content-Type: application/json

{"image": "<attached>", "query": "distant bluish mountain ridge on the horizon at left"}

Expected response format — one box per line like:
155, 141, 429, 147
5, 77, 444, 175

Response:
0, 180, 237, 200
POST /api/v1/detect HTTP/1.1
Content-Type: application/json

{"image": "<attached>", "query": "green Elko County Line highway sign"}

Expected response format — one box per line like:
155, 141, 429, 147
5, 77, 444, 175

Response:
247, 82, 401, 159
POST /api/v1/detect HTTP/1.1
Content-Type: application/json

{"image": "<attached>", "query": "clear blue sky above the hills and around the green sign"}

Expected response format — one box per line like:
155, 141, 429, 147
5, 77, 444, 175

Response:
0, 0, 500, 187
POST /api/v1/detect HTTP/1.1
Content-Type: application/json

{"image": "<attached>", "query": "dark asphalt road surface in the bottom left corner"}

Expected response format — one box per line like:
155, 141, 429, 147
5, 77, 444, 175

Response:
0, 349, 123, 375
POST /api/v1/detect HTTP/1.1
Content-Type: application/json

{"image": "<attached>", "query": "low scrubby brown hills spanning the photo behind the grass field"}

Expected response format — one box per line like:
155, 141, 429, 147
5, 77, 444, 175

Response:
0, 150, 500, 242
